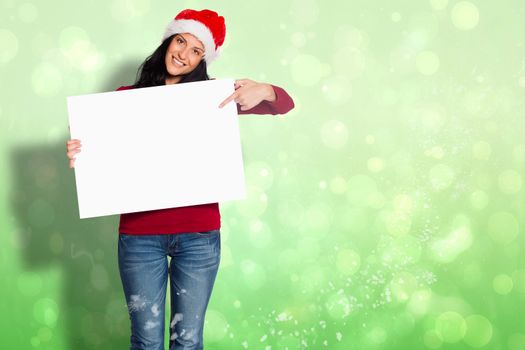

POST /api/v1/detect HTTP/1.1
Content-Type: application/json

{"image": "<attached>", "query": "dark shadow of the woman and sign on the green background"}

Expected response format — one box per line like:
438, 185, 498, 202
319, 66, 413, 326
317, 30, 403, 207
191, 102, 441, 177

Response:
10, 58, 140, 350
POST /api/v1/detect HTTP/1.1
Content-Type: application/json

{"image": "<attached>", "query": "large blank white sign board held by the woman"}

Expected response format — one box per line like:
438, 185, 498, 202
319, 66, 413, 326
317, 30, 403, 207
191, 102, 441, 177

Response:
67, 79, 245, 218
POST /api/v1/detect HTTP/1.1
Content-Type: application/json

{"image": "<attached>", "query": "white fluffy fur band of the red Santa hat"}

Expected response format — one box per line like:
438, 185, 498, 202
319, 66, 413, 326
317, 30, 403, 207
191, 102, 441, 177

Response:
162, 19, 219, 65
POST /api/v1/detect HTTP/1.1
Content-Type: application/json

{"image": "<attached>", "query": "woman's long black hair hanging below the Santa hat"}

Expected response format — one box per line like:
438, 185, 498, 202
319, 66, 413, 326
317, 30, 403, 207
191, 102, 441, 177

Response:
133, 34, 210, 88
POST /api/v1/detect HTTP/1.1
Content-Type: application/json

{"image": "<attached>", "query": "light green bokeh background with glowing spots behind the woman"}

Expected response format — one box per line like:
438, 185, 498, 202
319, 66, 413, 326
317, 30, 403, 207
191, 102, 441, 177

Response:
0, 0, 525, 350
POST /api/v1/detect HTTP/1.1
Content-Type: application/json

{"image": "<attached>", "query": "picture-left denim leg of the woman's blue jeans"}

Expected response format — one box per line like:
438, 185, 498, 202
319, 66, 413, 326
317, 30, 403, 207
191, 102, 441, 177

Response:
118, 234, 168, 350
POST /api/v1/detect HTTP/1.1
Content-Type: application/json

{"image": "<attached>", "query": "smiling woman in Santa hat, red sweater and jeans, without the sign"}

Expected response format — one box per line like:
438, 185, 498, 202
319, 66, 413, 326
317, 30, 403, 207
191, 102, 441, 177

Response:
67, 9, 294, 350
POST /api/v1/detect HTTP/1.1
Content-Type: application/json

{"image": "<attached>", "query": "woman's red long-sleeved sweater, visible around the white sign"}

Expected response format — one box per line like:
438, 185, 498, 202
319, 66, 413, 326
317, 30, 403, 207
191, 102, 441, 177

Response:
117, 85, 294, 235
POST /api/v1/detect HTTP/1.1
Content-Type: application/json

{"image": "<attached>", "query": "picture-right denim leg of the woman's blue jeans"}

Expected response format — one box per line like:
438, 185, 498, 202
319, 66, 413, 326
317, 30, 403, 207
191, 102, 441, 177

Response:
170, 230, 221, 350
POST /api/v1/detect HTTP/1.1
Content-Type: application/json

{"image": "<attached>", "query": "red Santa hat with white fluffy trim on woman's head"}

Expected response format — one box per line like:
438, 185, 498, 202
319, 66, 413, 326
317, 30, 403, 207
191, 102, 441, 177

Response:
162, 9, 226, 65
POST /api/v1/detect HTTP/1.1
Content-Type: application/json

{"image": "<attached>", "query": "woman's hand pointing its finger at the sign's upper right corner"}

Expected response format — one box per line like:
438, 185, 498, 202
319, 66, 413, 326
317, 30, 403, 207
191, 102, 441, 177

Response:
219, 79, 276, 111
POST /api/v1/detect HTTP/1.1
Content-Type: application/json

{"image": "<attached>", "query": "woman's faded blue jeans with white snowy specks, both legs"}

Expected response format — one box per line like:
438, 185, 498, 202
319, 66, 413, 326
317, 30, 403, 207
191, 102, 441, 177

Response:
118, 230, 221, 350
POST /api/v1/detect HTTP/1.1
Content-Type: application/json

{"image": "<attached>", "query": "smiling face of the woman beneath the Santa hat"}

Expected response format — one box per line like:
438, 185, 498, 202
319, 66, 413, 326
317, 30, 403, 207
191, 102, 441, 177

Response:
165, 33, 204, 84
